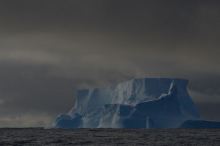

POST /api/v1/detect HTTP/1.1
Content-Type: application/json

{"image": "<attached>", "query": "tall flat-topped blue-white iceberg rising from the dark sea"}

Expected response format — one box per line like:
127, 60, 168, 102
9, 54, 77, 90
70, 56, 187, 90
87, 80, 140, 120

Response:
52, 78, 220, 129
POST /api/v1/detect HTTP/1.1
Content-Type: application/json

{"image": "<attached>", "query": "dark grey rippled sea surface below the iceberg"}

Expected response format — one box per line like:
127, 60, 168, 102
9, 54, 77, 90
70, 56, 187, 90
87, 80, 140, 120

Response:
0, 128, 220, 146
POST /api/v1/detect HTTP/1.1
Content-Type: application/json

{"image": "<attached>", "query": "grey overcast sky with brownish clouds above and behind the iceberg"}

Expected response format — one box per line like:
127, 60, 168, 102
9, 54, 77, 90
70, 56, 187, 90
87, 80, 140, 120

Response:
0, 0, 220, 127
